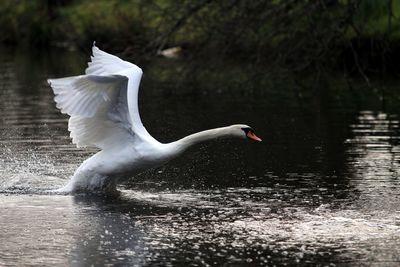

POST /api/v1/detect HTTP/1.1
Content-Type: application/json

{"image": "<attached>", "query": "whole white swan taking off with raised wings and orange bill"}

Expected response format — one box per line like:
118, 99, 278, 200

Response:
48, 45, 261, 193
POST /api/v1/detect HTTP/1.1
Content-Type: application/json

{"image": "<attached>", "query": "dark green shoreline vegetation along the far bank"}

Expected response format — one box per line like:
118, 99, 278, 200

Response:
0, 0, 400, 85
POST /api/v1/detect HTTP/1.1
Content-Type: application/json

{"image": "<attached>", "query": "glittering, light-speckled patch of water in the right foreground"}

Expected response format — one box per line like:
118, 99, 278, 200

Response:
115, 188, 400, 263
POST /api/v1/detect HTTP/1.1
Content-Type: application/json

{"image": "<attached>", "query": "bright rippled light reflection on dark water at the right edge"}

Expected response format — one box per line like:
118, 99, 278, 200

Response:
346, 111, 400, 213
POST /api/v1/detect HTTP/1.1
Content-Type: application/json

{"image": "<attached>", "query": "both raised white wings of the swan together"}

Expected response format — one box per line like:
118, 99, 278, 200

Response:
48, 46, 154, 149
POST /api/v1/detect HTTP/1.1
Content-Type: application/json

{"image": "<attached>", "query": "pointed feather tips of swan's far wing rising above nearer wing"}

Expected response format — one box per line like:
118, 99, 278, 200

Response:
85, 45, 137, 75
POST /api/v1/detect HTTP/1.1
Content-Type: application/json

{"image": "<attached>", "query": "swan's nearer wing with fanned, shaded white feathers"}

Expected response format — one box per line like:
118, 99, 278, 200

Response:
49, 75, 133, 149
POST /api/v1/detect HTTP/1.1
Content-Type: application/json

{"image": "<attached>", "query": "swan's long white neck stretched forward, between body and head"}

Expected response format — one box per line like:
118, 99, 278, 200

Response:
170, 126, 235, 152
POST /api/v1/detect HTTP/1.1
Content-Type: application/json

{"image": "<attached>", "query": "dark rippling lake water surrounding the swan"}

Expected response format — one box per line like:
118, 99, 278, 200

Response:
0, 48, 400, 266
